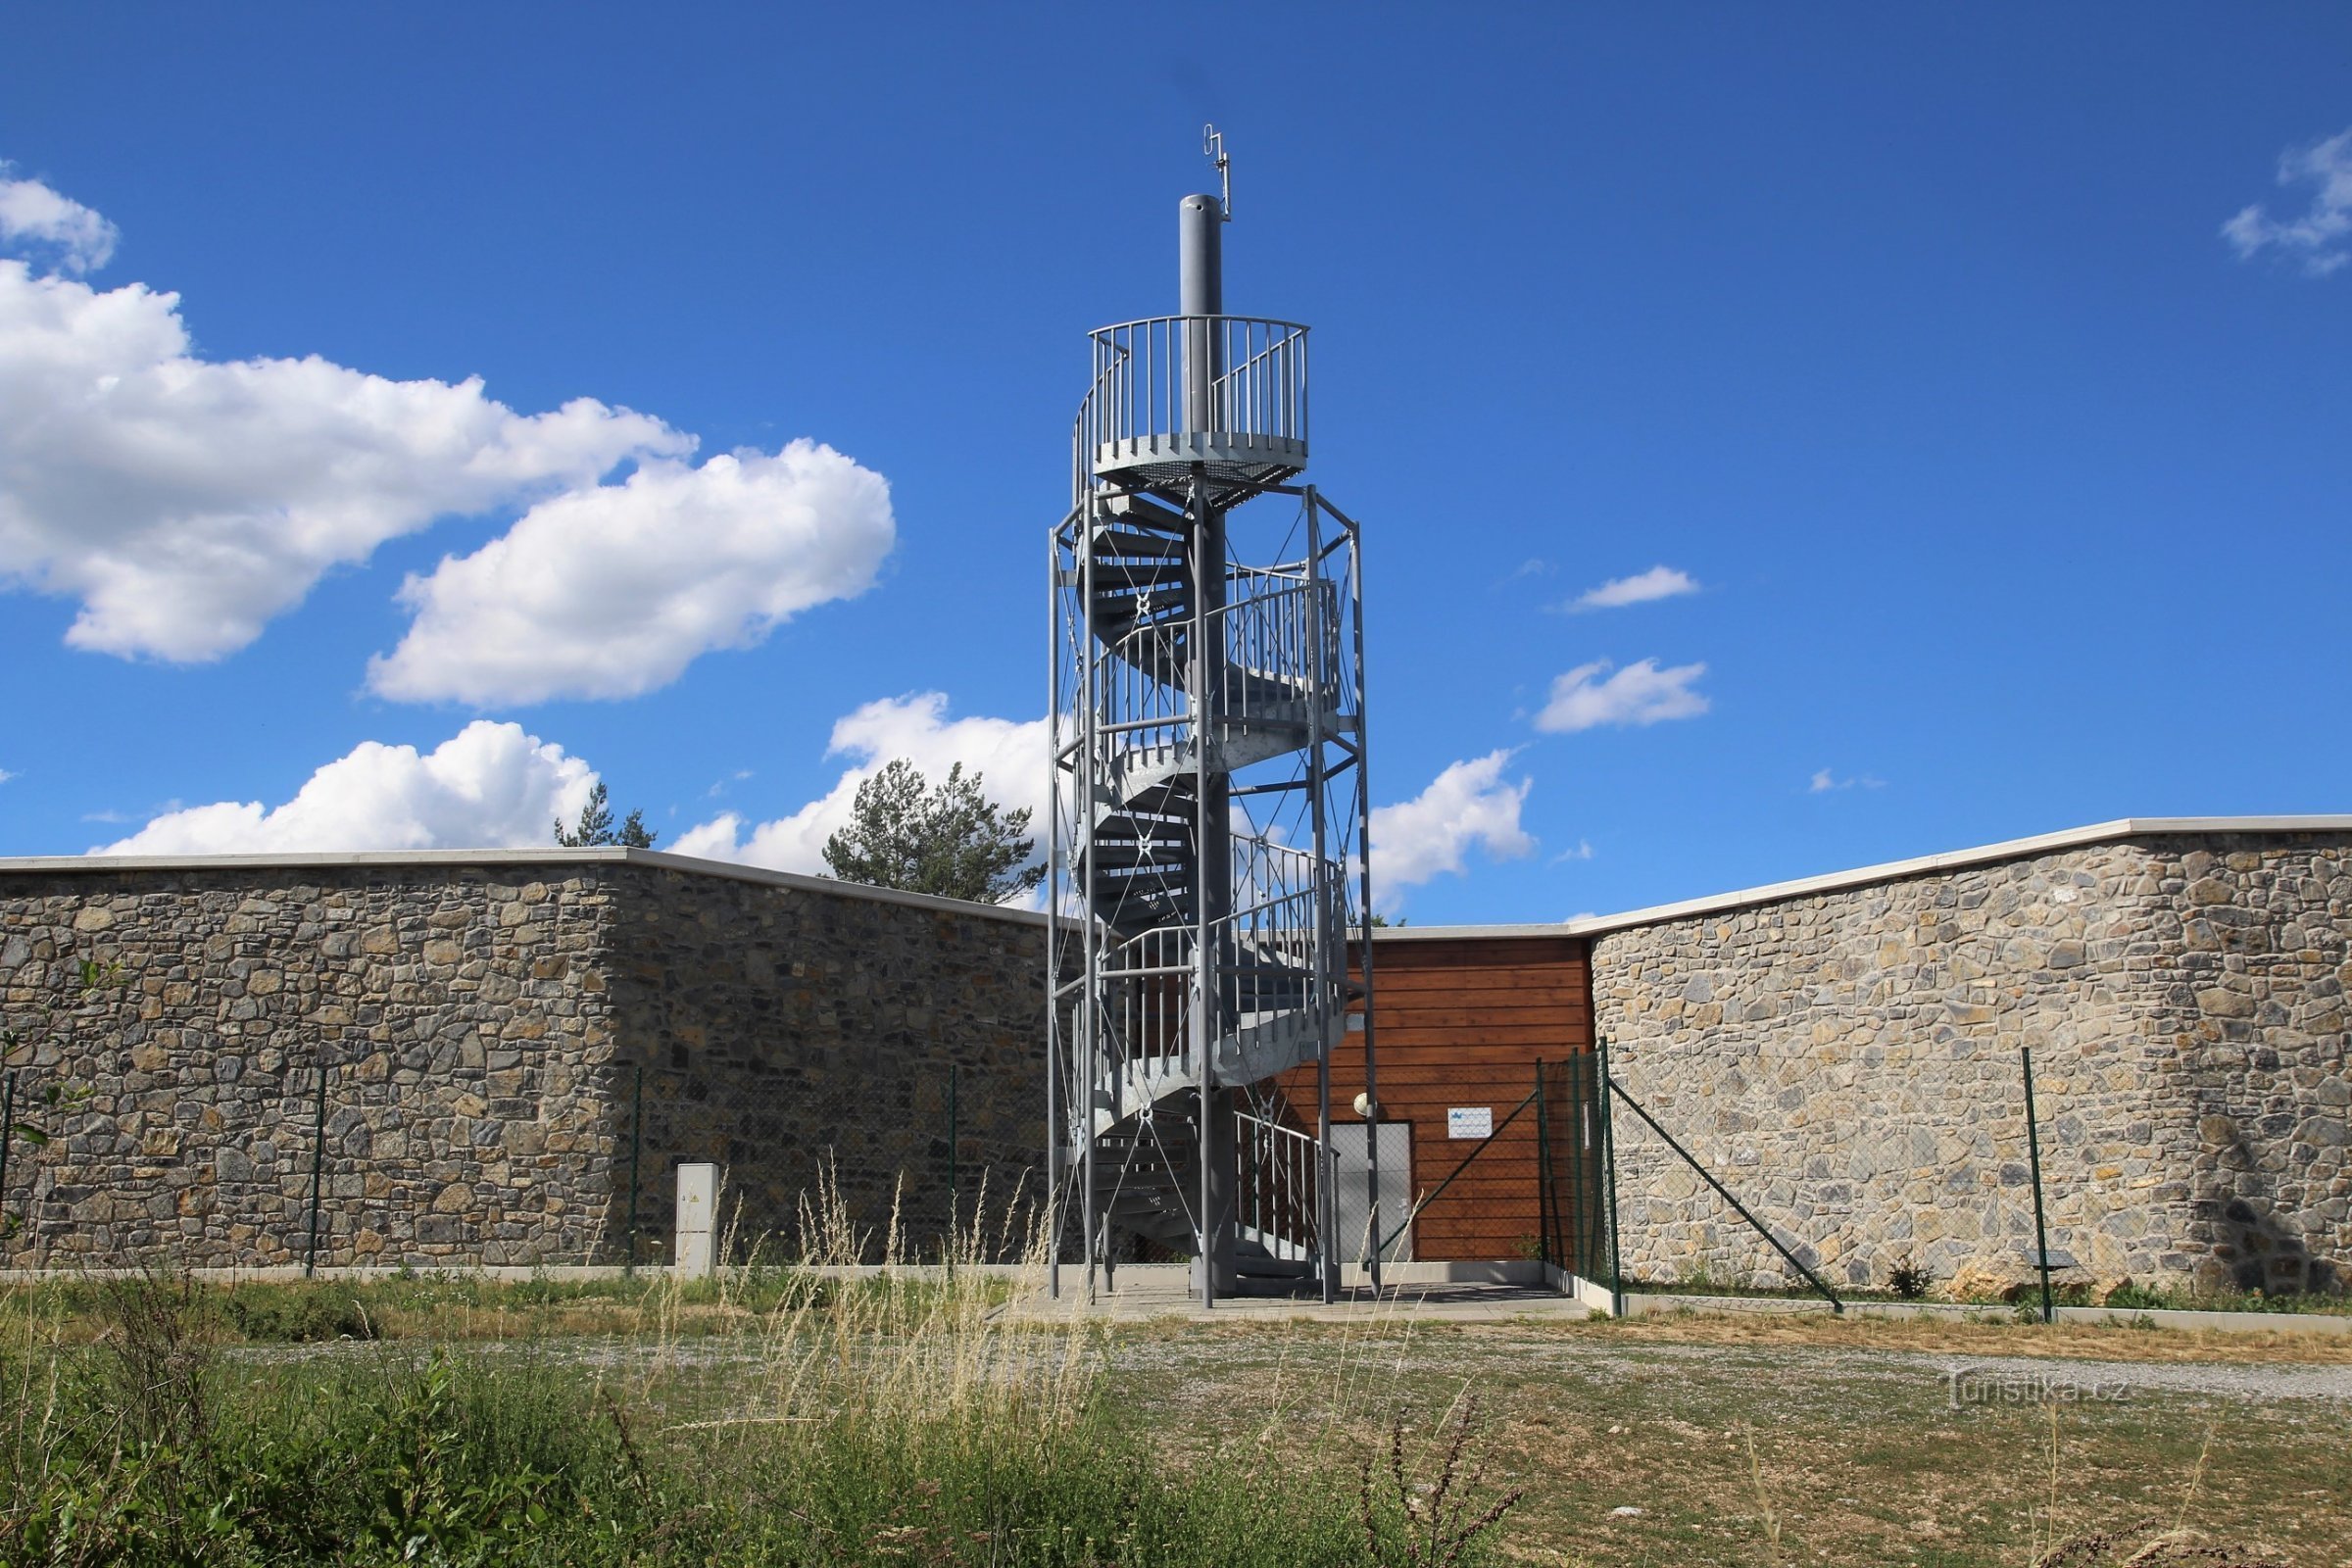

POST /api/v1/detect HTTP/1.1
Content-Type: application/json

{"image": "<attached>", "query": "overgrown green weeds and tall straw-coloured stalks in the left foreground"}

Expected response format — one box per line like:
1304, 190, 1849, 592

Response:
0, 1175, 1492, 1568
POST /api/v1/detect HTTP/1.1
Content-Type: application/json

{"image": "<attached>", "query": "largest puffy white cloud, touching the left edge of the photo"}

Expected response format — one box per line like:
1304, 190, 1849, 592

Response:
0, 250, 694, 661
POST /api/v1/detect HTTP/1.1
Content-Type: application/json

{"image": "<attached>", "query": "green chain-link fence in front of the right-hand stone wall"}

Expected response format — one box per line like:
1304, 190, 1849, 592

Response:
1539, 1044, 2342, 1312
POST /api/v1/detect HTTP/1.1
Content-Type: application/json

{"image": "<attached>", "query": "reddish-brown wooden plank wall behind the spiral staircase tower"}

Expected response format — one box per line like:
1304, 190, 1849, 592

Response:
1282, 936, 1592, 1260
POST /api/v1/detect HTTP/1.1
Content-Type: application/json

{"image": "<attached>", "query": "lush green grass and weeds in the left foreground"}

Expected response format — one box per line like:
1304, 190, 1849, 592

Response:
0, 1348, 1364, 1568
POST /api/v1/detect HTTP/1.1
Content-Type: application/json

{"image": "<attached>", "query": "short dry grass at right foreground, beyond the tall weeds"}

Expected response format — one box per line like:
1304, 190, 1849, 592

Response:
1091, 1319, 2352, 1568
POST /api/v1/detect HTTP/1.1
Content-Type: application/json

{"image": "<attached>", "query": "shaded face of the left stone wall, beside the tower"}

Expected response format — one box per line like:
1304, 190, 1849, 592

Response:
612, 870, 1045, 1257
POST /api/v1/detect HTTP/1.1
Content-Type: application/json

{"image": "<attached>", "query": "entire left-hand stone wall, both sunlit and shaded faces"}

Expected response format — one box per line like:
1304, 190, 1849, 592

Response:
0, 851, 1045, 1267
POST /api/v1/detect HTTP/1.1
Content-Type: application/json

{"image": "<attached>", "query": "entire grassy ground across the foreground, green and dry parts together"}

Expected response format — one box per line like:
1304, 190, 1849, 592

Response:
0, 1277, 2352, 1568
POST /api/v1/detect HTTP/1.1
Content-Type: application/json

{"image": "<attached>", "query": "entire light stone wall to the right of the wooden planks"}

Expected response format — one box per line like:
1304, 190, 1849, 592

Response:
1594, 832, 2352, 1291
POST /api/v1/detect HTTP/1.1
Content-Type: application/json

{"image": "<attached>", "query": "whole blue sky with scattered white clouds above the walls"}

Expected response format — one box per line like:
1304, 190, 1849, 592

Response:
0, 5, 2352, 924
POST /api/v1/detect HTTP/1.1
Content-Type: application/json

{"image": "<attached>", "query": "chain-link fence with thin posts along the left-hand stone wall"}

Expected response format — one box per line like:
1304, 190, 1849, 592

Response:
0, 1049, 1035, 1269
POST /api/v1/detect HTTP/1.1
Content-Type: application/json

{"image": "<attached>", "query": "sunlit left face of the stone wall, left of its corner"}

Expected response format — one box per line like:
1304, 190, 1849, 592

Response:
0, 865, 613, 1267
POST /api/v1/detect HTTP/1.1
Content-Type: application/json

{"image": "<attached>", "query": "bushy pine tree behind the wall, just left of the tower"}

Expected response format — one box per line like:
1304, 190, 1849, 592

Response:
825, 757, 1045, 903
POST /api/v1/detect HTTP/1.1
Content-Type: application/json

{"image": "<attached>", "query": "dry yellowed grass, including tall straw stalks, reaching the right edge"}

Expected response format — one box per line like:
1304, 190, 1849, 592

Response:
7, 1199, 2352, 1568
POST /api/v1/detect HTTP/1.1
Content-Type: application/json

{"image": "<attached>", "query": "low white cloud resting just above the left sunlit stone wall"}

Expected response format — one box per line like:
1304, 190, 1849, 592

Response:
89, 719, 595, 856
